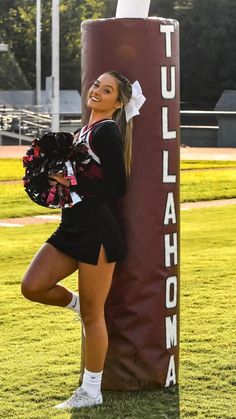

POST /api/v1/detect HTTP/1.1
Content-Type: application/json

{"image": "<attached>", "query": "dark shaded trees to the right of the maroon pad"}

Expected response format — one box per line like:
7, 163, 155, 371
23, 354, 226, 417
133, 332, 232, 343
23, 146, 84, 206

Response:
176, 0, 236, 107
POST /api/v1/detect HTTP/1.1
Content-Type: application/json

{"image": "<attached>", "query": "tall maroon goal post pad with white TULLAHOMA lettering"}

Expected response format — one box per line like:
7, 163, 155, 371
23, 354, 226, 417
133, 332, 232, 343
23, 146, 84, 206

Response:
82, 18, 180, 390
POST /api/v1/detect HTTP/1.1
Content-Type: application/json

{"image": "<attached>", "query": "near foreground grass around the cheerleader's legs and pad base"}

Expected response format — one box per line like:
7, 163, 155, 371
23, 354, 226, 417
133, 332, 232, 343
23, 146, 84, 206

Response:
0, 206, 236, 419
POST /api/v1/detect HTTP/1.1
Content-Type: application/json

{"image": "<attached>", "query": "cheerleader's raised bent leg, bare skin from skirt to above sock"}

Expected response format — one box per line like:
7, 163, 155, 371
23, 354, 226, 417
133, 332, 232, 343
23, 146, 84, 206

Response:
21, 243, 78, 307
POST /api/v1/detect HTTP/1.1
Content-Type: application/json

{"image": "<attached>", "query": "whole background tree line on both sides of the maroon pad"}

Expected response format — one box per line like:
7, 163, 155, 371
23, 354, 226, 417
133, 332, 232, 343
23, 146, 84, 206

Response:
0, 0, 236, 108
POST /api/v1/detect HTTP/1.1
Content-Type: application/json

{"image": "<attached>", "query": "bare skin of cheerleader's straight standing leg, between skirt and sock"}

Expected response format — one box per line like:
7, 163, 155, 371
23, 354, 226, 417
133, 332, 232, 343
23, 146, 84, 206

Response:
79, 246, 115, 372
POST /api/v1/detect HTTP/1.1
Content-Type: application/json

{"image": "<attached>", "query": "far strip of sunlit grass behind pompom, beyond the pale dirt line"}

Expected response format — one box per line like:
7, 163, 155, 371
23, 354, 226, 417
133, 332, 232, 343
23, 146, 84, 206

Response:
0, 159, 236, 218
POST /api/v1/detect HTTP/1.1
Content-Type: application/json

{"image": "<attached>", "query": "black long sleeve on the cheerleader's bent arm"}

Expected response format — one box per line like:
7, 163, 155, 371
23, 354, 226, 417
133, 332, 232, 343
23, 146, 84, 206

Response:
70, 122, 126, 198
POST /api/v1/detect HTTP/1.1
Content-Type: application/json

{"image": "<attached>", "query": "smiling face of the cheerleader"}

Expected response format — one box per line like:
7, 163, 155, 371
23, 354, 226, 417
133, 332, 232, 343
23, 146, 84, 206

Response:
87, 73, 121, 115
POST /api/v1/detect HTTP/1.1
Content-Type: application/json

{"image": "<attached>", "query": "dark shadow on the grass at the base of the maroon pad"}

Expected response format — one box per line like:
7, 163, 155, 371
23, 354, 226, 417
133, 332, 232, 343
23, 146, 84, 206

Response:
70, 386, 180, 419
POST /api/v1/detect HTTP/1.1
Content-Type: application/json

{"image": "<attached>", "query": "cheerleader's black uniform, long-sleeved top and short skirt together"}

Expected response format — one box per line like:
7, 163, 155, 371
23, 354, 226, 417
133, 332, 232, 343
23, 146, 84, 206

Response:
47, 120, 126, 265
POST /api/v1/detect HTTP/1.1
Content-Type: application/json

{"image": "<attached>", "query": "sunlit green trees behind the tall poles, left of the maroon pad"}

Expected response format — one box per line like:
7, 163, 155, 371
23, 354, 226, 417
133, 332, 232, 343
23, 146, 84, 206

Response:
0, 0, 105, 89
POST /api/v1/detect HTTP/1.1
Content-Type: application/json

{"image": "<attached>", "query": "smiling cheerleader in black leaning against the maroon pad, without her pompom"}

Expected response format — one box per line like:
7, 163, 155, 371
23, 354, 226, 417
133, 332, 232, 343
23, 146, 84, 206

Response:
22, 72, 144, 409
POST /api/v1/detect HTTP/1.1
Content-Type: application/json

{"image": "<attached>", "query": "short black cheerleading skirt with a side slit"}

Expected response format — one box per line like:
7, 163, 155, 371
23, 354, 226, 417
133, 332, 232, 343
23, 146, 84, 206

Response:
46, 198, 125, 265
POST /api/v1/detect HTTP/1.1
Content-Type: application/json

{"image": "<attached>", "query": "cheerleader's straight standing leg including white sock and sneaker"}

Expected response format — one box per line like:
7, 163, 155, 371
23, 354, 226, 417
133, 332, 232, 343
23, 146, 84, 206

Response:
55, 246, 115, 409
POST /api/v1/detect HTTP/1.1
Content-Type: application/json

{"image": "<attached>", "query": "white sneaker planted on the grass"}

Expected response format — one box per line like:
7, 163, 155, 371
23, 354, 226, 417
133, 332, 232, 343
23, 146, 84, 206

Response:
54, 387, 103, 409
